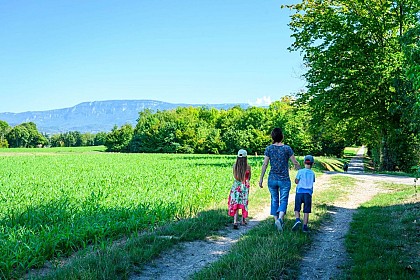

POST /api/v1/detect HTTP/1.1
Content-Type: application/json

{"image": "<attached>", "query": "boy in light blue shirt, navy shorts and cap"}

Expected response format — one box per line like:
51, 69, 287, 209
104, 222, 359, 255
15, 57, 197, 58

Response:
292, 155, 315, 232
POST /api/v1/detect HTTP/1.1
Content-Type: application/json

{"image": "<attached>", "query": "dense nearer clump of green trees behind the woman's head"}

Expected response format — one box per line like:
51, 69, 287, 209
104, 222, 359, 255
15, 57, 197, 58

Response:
124, 97, 344, 155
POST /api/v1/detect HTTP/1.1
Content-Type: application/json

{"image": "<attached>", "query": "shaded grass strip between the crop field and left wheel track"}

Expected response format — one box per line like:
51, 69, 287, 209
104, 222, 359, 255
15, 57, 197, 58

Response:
28, 209, 230, 280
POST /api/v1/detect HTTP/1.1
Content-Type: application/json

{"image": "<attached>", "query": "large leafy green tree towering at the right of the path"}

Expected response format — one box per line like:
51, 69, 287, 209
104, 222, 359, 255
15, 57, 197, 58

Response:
286, 0, 420, 170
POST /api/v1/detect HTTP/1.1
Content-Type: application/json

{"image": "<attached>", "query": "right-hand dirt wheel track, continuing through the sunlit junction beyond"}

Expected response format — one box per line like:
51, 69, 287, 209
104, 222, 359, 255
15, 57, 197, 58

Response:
299, 147, 413, 280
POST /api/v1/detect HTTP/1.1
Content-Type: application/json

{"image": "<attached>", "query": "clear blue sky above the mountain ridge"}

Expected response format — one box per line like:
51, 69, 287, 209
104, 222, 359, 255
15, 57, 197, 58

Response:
0, 0, 305, 112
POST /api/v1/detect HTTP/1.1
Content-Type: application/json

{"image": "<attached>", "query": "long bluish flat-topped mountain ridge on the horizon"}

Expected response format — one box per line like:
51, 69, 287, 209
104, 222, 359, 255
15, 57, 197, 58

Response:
0, 100, 249, 134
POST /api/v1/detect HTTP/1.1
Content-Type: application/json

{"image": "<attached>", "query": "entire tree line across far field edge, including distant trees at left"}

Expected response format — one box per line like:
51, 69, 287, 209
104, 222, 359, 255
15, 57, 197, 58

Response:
3, 96, 352, 158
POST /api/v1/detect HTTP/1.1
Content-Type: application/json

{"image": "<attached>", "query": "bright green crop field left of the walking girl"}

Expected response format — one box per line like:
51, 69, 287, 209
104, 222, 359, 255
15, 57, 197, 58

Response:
0, 149, 261, 278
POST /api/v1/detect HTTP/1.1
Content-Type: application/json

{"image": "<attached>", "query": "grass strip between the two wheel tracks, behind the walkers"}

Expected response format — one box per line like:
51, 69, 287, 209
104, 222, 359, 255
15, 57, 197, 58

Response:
192, 176, 354, 280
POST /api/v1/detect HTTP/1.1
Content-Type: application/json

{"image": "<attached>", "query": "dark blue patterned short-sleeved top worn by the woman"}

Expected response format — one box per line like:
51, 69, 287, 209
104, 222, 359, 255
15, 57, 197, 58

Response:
264, 145, 293, 181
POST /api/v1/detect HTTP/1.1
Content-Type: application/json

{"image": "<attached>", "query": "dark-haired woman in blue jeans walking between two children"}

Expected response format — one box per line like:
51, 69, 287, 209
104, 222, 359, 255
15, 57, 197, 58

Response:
259, 127, 300, 231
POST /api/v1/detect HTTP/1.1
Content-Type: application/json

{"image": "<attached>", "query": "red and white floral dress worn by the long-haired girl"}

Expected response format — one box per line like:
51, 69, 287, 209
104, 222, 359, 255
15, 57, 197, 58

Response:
228, 170, 250, 218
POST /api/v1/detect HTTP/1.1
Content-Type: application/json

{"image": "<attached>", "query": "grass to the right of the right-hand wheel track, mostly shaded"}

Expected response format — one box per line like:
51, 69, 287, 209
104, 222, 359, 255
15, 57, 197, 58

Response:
346, 184, 420, 279
